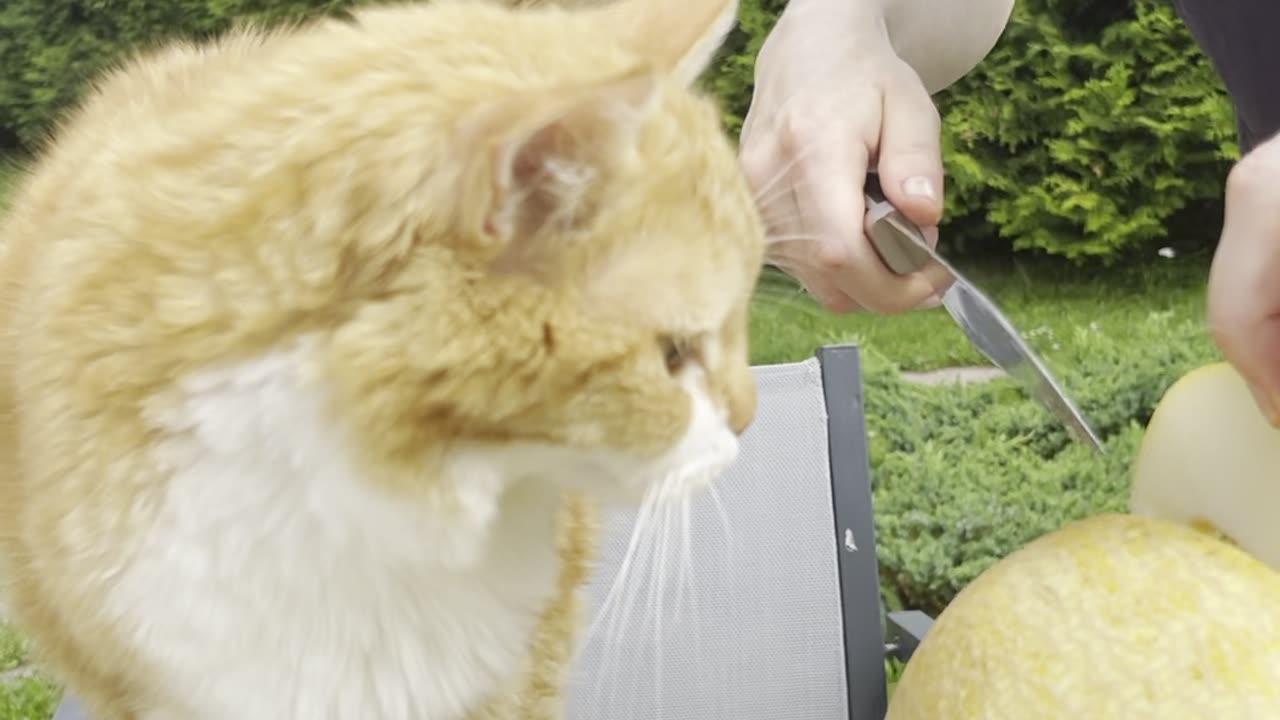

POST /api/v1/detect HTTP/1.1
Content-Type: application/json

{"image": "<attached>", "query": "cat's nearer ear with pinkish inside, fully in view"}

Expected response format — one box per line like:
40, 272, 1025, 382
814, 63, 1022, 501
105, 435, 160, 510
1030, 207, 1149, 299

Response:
463, 70, 659, 266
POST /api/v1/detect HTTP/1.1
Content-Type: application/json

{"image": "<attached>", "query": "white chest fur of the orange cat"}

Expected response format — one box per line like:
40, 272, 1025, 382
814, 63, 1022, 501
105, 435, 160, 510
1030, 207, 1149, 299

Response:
106, 345, 558, 720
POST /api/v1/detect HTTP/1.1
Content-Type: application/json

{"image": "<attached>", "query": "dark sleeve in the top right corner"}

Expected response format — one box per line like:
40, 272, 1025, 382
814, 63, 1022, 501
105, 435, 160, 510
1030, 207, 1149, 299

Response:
1174, 0, 1280, 152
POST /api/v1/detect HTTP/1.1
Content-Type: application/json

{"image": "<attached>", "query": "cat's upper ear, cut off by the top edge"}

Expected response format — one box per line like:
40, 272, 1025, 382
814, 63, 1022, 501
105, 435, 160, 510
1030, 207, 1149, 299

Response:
595, 0, 739, 85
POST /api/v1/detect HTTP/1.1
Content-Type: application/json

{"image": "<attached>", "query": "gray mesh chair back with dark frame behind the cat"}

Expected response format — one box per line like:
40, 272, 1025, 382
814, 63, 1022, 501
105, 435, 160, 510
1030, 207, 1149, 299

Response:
567, 346, 901, 720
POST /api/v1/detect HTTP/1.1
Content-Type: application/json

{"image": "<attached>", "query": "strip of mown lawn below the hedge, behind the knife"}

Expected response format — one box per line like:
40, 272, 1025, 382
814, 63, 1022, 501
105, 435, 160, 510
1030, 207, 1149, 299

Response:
751, 255, 1208, 370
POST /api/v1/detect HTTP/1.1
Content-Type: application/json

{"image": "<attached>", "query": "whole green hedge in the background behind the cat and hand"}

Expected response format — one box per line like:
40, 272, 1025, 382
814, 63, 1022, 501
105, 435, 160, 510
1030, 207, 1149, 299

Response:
0, 0, 1238, 260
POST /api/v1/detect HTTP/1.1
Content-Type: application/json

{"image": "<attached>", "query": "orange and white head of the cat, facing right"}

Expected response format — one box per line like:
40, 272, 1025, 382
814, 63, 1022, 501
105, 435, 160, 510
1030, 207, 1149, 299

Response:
325, 0, 764, 492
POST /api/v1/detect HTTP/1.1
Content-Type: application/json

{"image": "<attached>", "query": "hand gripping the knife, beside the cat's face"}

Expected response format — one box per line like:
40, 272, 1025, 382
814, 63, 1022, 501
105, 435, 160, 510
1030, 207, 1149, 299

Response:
741, 0, 943, 313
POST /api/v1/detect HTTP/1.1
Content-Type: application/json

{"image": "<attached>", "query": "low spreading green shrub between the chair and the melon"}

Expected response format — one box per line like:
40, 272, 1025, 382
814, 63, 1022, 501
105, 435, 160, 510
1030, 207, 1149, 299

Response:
864, 308, 1219, 612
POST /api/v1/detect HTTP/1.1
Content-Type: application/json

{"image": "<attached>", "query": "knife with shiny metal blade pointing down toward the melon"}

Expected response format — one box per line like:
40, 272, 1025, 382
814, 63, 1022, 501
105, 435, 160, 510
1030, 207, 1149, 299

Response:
863, 172, 1105, 452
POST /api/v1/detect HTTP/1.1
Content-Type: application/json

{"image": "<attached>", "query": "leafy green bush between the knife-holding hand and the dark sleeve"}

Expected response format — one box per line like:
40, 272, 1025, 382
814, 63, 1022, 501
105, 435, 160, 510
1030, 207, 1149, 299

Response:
940, 0, 1239, 260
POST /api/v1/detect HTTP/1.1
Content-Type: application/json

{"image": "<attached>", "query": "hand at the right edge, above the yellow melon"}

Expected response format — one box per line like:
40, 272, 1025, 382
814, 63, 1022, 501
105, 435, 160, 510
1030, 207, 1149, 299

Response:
1208, 137, 1280, 427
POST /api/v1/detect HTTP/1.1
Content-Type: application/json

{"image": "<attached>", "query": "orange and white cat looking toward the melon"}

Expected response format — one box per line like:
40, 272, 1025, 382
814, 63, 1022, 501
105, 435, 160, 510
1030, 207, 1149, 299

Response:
0, 0, 764, 720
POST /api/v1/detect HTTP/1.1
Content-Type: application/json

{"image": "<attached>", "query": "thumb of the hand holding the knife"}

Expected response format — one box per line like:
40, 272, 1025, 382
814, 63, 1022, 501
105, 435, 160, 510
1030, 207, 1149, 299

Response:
877, 63, 942, 227
